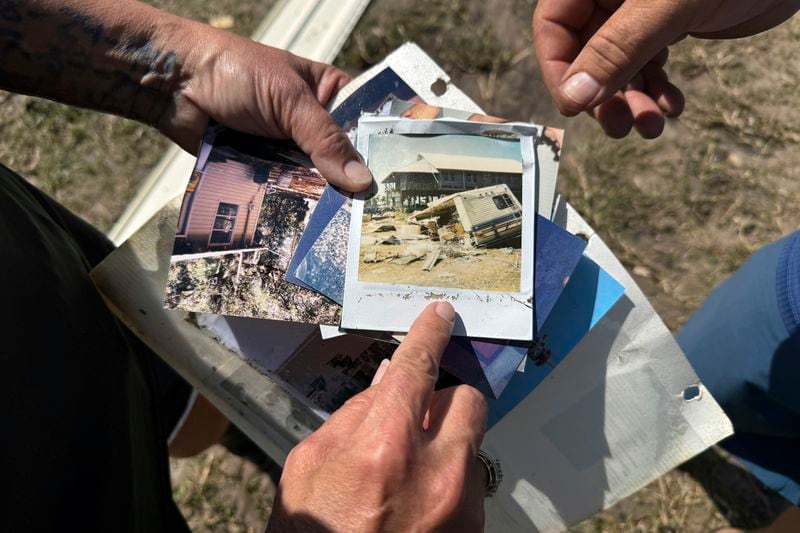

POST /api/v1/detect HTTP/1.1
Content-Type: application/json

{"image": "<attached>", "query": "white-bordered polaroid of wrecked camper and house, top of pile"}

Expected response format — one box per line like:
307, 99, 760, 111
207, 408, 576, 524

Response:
342, 118, 539, 341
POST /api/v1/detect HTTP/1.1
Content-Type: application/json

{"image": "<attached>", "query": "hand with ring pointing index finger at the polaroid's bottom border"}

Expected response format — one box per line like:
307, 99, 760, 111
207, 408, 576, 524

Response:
268, 303, 486, 531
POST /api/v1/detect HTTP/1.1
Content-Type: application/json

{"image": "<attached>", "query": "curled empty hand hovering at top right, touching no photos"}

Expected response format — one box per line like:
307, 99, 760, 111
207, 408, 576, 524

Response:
533, 0, 800, 139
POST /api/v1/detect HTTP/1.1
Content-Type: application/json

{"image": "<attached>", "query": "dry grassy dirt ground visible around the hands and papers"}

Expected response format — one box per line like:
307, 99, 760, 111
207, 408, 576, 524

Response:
0, 0, 800, 532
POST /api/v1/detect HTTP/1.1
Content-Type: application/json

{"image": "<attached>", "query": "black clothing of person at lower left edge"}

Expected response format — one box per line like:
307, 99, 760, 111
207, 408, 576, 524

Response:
0, 165, 190, 533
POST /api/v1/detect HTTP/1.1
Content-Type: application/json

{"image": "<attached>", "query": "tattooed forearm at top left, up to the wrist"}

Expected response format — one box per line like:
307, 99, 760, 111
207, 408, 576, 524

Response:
0, 0, 210, 125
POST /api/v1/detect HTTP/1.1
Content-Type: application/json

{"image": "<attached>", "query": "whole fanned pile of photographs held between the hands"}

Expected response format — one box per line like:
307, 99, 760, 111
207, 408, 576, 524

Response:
165, 58, 624, 424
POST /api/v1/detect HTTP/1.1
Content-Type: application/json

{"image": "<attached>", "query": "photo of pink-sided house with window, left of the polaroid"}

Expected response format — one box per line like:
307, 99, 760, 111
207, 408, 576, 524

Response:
165, 126, 340, 324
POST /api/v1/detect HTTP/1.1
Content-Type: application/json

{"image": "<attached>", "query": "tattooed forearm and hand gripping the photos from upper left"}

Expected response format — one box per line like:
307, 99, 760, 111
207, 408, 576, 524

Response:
0, 0, 372, 191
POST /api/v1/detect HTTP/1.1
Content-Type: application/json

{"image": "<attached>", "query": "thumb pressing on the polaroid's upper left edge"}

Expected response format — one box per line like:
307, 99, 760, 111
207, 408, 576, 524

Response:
287, 88, 372, 192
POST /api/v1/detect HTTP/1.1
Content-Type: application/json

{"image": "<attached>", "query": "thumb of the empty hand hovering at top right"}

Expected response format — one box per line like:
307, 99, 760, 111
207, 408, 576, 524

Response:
556, 0, 689, 116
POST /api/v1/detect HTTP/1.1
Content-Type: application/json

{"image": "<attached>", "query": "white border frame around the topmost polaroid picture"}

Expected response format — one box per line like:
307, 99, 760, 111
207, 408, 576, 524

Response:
342, 117, 540, 341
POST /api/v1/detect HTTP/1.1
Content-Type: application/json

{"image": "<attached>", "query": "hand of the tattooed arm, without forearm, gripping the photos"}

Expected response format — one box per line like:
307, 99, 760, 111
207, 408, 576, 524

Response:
163, 25, 372, 191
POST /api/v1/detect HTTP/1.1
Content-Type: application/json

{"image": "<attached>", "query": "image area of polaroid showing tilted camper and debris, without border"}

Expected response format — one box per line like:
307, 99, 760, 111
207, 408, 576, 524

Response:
358, 134, 523, 292
